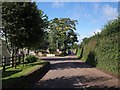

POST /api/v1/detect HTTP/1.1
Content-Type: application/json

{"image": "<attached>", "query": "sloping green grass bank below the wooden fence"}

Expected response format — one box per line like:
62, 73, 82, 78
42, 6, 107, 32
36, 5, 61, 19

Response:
2, 60, 47, 86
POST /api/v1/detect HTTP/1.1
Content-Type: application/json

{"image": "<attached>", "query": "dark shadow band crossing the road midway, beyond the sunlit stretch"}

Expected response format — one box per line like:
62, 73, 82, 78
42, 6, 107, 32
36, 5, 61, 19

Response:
51, 62, 92, 70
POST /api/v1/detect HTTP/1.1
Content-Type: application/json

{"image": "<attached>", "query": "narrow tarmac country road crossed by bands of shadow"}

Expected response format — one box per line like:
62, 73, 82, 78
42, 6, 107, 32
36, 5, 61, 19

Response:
32, 56, 118, 90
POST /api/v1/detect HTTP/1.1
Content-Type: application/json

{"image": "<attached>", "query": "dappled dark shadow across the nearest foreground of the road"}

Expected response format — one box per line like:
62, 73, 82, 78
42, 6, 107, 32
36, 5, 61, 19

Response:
33, 76, 117, 89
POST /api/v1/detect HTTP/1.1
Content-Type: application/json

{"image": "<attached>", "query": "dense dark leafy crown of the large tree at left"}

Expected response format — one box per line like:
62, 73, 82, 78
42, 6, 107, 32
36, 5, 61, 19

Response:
2, 2, 47, 55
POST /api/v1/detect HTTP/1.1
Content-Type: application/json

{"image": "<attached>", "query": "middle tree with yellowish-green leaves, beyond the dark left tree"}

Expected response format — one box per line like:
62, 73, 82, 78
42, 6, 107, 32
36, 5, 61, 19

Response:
50, 18, 77, 53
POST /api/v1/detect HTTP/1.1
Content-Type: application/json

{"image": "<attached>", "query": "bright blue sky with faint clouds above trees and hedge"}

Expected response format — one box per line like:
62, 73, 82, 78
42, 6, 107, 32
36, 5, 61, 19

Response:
36, 2, 118, 42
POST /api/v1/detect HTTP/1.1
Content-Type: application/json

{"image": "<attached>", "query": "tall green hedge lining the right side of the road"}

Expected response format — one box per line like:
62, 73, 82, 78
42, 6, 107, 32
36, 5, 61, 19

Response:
77, 18, 120, 74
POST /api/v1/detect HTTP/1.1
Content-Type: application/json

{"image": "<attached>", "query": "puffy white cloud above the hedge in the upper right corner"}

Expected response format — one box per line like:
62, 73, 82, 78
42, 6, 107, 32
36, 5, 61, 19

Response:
103, 4, 118, 19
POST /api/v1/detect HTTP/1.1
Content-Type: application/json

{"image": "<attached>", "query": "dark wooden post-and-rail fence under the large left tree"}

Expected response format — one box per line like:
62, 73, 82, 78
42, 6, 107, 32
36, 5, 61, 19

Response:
1, 54, 27, 71
